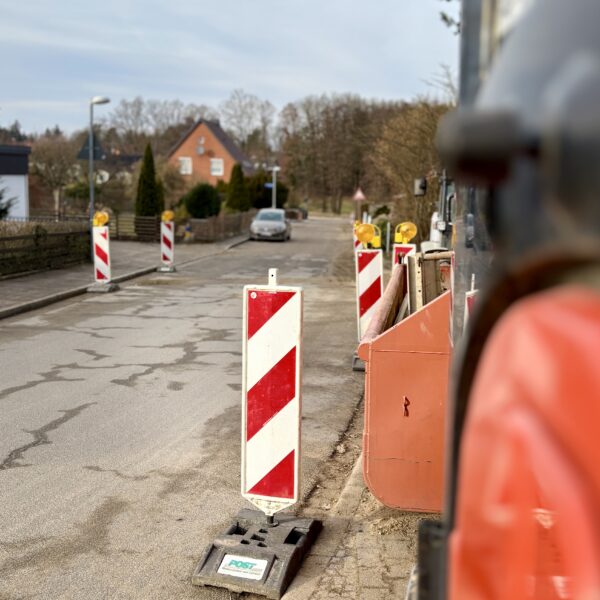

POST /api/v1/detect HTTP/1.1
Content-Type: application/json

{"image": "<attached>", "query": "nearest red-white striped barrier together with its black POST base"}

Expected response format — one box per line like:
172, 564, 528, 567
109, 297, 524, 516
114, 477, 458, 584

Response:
192, 269, 322, 598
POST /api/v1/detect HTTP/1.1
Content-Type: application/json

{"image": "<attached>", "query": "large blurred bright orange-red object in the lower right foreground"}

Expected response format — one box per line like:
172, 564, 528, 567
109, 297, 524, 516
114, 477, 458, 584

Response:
450, 287, 600, 600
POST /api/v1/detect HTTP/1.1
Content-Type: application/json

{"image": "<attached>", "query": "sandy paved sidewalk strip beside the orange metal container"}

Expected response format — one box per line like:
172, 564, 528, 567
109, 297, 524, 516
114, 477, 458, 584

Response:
282, 404, 435, 600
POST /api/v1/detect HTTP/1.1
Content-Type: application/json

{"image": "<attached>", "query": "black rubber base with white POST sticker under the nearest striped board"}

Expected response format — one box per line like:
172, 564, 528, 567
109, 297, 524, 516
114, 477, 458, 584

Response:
192, 509, 322, 600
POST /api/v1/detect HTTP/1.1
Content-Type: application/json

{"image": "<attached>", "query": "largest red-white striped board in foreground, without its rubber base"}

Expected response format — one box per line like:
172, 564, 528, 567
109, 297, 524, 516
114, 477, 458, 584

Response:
241, 270, 303, 516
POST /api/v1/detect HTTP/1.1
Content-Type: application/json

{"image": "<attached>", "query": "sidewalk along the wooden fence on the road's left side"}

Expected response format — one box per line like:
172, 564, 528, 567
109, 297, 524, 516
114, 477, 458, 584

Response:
0, 235, 248, 319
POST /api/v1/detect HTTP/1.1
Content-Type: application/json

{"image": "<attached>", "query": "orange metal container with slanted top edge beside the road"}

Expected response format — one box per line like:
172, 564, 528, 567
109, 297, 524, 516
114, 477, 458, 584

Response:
358, 267, 450, 512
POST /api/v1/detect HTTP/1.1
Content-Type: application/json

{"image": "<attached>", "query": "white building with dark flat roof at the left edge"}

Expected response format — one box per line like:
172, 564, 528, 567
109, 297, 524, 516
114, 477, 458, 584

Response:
0, 145, 31, 217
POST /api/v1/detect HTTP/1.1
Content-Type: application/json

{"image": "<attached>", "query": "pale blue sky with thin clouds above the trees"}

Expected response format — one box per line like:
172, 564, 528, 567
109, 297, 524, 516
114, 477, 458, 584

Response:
0, 0, 459, 133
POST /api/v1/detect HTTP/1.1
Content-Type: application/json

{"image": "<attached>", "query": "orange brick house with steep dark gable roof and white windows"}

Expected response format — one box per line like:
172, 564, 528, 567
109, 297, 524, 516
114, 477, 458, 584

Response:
169, 119, 253, 185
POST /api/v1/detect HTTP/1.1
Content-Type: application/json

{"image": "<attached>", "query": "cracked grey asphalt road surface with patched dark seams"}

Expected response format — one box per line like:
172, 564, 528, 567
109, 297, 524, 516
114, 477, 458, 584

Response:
0, 219, 362, 600
